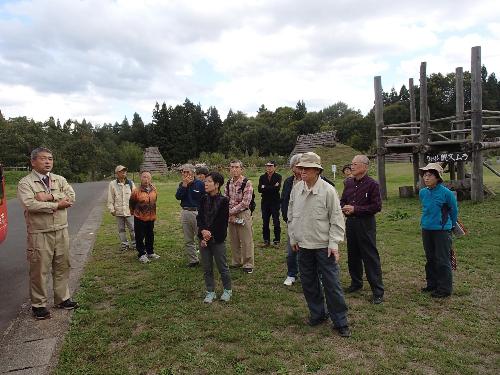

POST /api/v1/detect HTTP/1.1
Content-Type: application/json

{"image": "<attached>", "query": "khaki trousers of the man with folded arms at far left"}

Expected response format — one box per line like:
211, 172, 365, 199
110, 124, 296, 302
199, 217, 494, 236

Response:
28, 228, 70, 307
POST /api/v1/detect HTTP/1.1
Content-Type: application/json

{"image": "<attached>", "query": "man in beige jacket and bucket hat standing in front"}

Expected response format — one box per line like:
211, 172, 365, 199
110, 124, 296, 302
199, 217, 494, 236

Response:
287, 152, 351, 337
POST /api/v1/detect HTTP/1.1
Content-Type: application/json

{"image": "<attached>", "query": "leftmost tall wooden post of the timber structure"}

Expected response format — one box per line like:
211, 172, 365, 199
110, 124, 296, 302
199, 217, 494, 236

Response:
374, 76, 387, 199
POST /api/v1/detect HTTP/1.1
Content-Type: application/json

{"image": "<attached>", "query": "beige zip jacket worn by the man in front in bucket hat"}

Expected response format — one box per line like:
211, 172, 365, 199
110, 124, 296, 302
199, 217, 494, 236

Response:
288, 178, 345, 249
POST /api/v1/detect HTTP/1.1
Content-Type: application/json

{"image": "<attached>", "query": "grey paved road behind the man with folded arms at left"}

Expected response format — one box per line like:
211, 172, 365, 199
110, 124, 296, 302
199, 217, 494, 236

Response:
0, 182, 107, 368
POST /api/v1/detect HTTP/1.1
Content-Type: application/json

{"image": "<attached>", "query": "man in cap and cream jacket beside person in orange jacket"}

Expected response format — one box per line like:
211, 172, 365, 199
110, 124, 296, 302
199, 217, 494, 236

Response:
108, 165, 135, 250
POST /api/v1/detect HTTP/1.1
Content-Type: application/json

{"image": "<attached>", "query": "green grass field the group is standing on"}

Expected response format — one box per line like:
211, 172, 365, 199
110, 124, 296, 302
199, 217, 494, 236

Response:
51, 156, 500, 375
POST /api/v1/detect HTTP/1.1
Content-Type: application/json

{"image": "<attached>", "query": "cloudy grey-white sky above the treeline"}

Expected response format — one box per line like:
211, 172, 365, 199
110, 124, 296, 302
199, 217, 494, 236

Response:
0, 0, 500, 124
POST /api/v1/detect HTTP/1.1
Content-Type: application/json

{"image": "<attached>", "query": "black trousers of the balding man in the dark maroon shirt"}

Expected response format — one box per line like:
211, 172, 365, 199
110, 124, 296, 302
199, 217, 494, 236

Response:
346, 215, 384, 296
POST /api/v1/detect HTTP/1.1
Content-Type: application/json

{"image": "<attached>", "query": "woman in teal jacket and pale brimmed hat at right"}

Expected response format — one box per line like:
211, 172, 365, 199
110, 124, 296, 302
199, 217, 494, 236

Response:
419, 163, 458, 298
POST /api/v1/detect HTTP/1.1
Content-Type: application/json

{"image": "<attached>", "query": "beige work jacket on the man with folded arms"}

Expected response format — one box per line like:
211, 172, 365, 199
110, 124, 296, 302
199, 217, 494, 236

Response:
17, 171, 75, 233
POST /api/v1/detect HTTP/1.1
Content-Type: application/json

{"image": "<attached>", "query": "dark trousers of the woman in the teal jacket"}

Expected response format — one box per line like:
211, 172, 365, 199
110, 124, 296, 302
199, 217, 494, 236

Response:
422, 229, 453, 294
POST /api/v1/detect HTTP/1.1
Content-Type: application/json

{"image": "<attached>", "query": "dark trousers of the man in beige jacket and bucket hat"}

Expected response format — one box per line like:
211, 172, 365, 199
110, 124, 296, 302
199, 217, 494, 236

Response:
299, 248, 348, 327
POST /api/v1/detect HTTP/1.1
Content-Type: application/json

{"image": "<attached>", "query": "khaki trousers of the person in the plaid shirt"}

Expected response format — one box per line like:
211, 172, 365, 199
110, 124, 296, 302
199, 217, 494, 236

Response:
228, 210, 254, 268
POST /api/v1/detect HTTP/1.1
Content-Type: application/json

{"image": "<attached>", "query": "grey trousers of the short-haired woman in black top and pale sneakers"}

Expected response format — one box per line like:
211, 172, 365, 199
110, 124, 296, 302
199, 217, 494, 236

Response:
200, 242, 231, 292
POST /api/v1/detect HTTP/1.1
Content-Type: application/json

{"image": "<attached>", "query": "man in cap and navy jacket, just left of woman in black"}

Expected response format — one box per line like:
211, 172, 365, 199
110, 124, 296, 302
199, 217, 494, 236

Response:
175, 164, 205, 267
